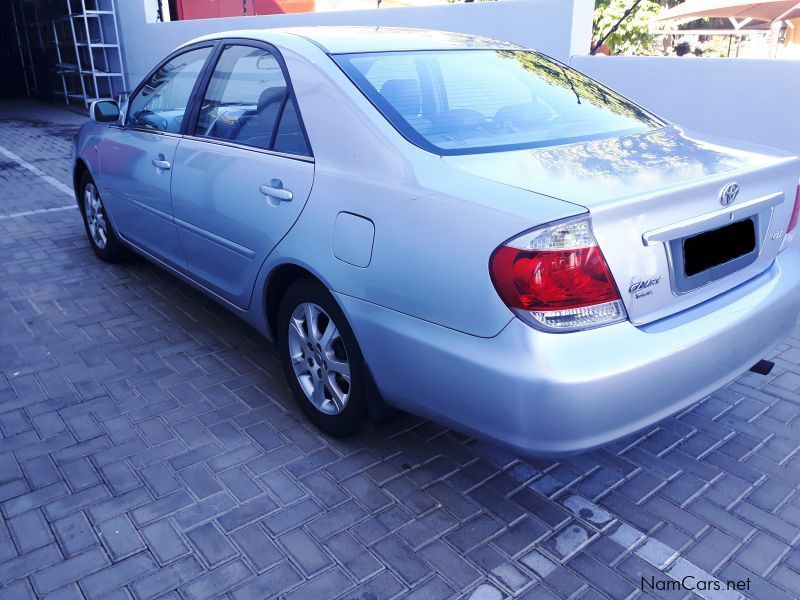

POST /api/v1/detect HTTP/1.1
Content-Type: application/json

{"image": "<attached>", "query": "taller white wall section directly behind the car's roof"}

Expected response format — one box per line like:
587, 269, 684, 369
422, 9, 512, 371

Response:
117, 0, 594, 89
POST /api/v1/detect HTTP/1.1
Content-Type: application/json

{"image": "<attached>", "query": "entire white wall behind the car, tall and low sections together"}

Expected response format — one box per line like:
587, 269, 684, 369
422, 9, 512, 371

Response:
111, 0, 800, 154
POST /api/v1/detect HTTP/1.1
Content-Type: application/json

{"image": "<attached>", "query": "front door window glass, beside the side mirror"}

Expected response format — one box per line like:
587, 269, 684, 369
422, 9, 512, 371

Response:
126, 47, 212, 133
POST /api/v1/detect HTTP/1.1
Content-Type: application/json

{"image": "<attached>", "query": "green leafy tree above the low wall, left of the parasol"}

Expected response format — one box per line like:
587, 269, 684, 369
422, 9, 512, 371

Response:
594, 0, 674, 54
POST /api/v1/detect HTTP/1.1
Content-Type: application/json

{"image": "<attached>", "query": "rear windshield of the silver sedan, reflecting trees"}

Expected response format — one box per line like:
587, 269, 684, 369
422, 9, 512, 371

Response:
333, 50, 664, 154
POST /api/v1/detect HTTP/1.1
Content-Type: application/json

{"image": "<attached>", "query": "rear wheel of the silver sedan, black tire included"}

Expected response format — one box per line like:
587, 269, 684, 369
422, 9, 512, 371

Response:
277, 279, 367, 437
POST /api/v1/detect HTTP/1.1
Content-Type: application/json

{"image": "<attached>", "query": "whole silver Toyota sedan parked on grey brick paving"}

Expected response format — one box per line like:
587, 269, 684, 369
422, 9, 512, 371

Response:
74, 28, 800, 455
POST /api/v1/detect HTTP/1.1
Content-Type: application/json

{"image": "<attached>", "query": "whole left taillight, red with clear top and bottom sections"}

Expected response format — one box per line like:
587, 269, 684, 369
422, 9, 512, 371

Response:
489, 217, 625, 331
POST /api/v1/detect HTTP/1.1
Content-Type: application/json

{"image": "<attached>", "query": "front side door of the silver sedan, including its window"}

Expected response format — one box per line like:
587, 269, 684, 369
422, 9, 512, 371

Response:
99, 44, 214, 271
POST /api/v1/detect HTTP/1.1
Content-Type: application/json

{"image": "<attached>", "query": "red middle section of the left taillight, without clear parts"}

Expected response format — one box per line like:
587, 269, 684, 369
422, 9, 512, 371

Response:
492, 246, 619, 310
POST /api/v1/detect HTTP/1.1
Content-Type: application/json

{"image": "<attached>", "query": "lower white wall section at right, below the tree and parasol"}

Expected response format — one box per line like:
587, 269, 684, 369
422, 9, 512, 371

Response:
571, 56, 800, 154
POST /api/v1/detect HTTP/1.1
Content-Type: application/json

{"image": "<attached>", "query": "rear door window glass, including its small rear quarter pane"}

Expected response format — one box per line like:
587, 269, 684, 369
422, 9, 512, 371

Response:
194, 46, 309, 155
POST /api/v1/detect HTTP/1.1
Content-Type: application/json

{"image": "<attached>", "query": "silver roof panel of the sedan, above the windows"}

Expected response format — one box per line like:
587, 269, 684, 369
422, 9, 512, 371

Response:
185, 26, 522, 54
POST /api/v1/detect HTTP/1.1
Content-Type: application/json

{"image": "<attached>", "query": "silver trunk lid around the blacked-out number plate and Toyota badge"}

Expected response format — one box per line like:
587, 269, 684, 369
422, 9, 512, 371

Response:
442, 127, 800, 324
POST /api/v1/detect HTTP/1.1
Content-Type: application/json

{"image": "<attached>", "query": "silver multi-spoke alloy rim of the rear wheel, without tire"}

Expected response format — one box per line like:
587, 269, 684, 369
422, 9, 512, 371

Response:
289, 302, 351, 415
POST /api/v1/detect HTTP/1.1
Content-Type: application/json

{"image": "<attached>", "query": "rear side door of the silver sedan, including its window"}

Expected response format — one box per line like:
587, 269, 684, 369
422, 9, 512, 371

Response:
172, 41, 314, 308
